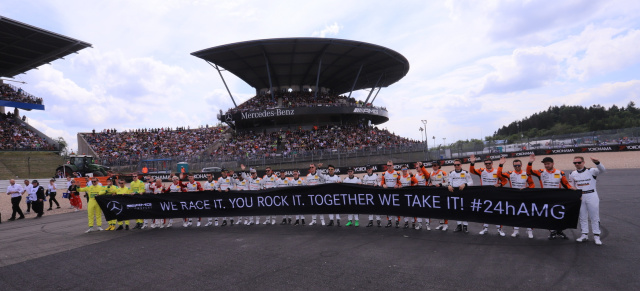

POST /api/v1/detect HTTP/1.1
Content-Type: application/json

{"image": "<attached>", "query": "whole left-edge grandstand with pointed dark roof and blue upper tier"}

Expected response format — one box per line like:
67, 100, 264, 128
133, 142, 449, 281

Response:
0, 16, 91, 179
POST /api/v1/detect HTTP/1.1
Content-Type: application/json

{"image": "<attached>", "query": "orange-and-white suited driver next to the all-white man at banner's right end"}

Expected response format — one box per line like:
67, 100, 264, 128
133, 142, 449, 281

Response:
527, 154, 573, 239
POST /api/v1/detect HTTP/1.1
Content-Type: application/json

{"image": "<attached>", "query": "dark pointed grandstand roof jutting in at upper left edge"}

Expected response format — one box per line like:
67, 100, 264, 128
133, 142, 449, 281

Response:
0, 16, 91, 77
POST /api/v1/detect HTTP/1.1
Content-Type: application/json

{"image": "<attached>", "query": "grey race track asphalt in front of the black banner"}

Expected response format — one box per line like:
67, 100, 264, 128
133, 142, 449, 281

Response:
0, 169, 640, 290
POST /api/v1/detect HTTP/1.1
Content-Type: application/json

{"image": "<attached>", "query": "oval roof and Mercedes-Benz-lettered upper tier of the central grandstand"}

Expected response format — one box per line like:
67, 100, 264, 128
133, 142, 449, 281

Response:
192, 38, 409, 130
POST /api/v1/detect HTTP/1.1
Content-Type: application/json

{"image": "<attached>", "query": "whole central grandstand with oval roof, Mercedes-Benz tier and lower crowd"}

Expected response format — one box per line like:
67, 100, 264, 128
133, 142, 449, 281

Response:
78, 38, 423, 170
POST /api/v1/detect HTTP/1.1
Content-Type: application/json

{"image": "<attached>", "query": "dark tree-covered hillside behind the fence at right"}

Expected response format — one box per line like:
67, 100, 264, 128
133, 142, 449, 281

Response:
491, 101, 640, 140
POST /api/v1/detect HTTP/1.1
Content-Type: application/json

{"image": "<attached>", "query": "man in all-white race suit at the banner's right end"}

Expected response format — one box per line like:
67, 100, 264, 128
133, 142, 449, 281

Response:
569, 156, 606, 245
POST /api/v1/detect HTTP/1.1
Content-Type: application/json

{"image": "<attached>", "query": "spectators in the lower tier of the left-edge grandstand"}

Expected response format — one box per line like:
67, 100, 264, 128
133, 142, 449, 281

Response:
0, 113, 56, 151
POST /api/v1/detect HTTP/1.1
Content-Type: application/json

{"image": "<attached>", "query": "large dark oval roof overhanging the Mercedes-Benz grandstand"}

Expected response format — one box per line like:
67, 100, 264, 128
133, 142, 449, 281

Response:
191, 38, 409, 94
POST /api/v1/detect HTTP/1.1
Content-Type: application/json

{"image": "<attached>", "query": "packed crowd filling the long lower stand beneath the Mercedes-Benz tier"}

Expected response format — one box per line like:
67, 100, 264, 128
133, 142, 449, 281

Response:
82, 124, 420, 165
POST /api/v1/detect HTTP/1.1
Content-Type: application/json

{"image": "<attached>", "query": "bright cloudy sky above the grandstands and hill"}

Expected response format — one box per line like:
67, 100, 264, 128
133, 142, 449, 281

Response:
0, 0, 640, 149
